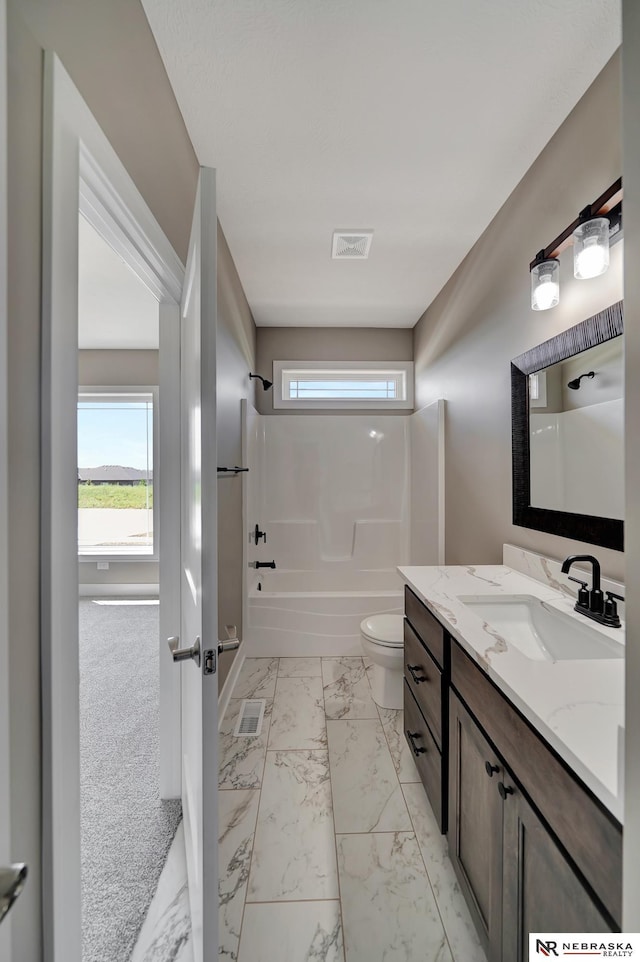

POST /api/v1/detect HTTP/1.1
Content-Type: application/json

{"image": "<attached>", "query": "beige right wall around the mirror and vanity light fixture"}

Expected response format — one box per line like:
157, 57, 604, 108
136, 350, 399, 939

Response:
414, 55, 624, 577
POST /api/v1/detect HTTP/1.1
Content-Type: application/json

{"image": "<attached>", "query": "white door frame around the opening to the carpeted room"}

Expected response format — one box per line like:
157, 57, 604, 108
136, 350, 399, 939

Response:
40, 52, 184, 962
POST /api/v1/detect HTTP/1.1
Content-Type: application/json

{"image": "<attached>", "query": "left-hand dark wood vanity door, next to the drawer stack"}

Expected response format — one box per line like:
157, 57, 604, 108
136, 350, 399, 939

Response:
449, 691, 504, 962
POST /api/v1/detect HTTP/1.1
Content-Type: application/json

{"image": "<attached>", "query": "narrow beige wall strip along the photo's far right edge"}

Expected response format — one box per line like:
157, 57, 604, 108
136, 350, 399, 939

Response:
622, 0, 640, 932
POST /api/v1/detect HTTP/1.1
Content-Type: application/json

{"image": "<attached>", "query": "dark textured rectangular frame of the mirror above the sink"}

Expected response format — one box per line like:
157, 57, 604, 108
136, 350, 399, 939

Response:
511, 301, 624, 551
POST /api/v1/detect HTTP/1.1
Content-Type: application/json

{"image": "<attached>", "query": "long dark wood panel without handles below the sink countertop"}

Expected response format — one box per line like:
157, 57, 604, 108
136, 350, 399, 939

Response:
451, 642, 622, 924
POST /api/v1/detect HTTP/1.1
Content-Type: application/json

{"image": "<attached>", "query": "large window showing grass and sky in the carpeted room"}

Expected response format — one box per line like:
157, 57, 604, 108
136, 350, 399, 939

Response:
78, 388, 157, 560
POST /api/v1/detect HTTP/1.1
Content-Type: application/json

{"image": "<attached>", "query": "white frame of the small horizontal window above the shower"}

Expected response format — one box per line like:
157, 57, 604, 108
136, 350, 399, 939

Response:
273, 361, 413, 411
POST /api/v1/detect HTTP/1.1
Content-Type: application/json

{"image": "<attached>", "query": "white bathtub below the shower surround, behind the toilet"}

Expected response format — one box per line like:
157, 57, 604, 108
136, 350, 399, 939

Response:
244, 569, 403, 657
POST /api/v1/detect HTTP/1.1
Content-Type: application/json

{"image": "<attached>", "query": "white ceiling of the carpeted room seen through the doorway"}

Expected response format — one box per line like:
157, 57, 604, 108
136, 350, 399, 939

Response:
78, 215, 159, 351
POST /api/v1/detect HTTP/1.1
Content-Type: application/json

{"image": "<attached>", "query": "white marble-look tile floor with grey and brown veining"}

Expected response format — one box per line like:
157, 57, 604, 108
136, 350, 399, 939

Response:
131, 658, 486, 962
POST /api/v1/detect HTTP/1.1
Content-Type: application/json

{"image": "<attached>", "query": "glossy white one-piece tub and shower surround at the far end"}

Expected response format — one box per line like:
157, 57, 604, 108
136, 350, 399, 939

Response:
243, 402, 442, 657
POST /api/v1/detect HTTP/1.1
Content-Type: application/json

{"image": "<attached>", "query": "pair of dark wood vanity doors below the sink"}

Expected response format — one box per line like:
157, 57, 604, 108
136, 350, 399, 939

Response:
448, 693, 613, 962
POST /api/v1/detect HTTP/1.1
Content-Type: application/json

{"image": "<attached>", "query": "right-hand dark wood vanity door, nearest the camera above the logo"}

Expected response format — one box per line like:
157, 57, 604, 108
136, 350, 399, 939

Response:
503, 778, 612, 962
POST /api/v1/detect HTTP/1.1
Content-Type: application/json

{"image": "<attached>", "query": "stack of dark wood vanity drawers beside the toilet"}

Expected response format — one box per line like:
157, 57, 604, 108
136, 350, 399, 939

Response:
404, 588, 449, 833
